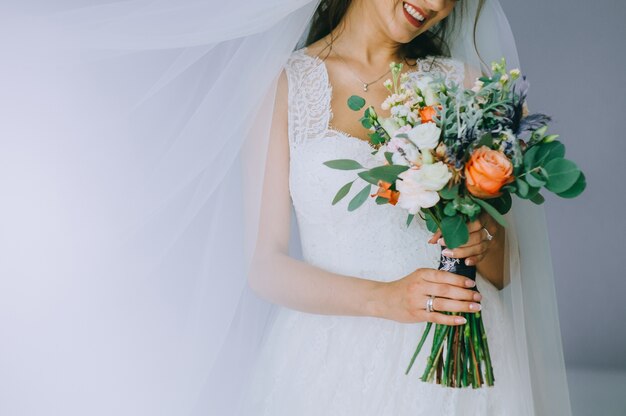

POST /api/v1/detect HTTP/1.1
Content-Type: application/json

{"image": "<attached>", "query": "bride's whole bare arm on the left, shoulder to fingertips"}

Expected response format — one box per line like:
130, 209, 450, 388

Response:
248, 72, 474, 325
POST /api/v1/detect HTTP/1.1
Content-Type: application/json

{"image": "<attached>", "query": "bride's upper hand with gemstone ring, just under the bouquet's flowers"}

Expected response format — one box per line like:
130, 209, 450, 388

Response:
428, 211, 500, 266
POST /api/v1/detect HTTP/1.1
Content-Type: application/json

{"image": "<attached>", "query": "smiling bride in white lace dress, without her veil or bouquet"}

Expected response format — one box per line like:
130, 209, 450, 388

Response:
241, 0, 532, 416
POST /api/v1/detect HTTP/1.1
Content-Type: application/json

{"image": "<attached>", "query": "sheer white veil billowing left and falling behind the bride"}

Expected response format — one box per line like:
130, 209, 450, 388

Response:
0, 0, 571, 416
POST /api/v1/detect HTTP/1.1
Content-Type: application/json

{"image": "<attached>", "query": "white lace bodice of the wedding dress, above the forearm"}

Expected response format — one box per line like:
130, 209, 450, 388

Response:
285, 48, 464, 280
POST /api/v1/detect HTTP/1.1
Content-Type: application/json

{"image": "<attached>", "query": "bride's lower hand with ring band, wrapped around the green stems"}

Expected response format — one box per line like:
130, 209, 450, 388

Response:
375, 268, 482, 325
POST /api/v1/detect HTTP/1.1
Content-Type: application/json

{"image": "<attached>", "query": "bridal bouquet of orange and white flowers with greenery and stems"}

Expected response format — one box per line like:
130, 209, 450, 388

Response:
324, 60, 586, 388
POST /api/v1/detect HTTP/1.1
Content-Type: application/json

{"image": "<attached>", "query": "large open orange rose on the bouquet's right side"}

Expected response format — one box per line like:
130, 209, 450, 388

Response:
465, 146, 514, 198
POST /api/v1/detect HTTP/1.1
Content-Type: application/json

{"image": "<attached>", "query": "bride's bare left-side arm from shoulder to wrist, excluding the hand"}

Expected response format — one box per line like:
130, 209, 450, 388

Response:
248, 72, 378, 316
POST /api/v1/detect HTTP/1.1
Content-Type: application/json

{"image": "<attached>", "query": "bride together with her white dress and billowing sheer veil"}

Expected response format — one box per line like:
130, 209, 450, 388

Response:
0, 0, 571, 416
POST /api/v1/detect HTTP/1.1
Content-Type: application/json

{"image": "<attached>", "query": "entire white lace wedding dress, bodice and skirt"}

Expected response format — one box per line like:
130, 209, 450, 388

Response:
243, 48, 529, 416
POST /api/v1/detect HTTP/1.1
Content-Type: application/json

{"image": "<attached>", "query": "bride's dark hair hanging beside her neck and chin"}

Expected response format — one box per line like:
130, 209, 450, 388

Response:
305, 0, 484, 63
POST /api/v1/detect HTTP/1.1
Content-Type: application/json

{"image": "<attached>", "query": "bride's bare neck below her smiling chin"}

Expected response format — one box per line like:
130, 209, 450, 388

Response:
332, 0, 402, 68
